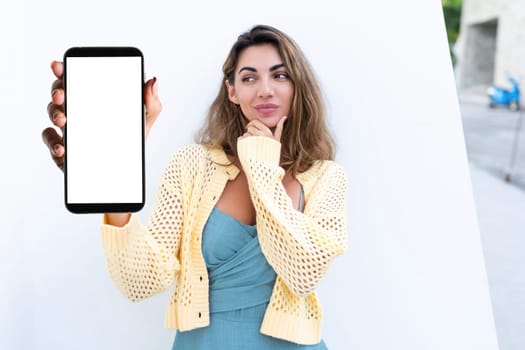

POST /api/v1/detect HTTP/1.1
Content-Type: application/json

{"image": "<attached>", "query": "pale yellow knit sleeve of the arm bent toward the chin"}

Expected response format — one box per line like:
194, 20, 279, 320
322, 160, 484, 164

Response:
238, 136, 348, 297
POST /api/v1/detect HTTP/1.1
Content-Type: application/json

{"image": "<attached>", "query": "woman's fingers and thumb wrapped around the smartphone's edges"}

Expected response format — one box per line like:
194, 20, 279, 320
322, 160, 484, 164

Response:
42, 61, 162, 171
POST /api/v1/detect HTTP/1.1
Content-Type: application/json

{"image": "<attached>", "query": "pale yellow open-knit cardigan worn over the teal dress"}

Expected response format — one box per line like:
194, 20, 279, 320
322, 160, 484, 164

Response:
101, 136, 347, 344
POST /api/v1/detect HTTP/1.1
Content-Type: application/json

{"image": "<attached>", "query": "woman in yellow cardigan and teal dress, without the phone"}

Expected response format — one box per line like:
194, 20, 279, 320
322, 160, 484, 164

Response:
43, 26, 347, 349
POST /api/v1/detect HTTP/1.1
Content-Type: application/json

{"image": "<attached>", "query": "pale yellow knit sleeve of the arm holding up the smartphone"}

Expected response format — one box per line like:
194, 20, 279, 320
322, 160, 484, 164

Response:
101, 151, 187, 301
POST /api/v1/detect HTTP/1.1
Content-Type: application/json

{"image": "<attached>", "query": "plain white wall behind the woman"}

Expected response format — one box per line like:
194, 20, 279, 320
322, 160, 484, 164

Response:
0, 0, 497, 350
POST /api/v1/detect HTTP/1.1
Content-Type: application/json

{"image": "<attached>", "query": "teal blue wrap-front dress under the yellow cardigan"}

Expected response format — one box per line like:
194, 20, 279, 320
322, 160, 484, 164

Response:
172, 191, 327, 350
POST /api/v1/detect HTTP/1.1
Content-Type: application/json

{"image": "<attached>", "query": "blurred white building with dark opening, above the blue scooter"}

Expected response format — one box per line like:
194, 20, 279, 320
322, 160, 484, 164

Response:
453, 0, 525, 90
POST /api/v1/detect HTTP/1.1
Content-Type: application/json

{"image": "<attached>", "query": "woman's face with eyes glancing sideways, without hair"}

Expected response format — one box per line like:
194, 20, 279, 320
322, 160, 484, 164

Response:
226, 44, 294, 128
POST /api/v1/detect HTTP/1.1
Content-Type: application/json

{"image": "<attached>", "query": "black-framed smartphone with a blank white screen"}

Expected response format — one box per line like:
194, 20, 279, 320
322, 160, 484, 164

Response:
63, 47, 145, 213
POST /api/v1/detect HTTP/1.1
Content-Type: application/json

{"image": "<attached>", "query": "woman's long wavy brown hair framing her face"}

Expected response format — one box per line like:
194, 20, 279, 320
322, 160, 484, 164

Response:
196, 25, 335, 175
